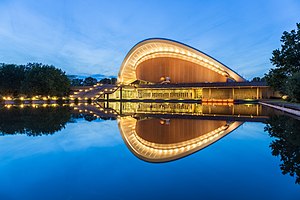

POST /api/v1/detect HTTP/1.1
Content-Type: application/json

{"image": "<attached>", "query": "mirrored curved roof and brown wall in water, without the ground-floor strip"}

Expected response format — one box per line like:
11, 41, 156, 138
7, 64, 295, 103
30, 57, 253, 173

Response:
119, 117, 243, 162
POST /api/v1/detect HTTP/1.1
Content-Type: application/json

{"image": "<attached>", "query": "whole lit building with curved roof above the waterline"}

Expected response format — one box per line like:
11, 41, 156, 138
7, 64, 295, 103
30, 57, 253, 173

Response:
104, 38, 272, 102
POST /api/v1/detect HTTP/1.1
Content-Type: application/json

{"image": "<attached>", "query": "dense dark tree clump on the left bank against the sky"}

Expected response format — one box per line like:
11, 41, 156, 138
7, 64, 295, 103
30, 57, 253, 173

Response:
0, 63, 70, 97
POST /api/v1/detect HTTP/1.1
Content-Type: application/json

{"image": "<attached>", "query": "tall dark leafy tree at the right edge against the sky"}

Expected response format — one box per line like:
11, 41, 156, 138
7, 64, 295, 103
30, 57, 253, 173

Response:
265, 23, 300, 95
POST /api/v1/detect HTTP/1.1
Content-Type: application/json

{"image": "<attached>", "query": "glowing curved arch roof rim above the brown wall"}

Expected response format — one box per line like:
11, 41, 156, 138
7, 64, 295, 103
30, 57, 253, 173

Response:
118, 38, 245, 84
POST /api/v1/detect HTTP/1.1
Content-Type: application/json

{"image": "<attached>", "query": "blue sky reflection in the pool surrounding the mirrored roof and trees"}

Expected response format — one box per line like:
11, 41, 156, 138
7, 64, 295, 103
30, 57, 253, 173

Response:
0, 104, 300, 199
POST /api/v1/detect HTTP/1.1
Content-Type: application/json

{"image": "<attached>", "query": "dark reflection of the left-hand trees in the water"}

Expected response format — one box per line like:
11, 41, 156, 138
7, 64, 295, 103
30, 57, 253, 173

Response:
0, 106, 116, 136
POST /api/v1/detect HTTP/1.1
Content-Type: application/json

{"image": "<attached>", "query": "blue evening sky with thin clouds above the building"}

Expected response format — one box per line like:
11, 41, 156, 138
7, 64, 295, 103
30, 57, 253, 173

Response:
0, 0, 300, 79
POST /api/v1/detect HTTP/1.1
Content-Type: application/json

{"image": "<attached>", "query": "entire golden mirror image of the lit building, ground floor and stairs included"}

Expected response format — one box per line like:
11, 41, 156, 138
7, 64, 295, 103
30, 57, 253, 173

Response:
75, 102, 268, 162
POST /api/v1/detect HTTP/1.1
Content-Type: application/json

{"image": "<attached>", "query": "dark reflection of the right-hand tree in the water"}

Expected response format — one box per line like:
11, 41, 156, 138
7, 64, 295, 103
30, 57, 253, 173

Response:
265, 115, 300, 184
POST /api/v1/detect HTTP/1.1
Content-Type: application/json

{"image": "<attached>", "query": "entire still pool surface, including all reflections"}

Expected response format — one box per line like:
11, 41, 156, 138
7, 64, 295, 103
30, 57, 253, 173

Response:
0, 102, 300, 200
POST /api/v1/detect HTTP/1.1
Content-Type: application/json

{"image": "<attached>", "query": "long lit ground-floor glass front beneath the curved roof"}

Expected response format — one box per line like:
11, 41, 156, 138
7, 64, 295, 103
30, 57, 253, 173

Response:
103, 86, 267, 101
